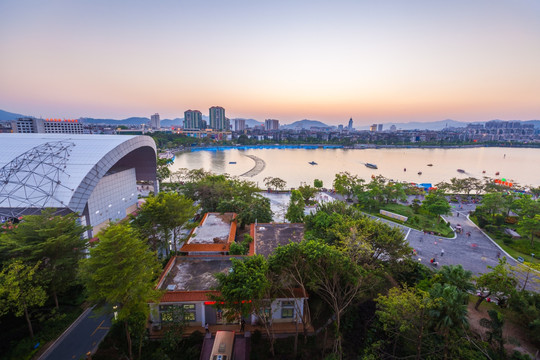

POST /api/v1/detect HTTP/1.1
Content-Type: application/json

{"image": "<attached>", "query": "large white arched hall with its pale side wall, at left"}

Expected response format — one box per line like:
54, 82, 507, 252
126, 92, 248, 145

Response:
0, 134, 159, 237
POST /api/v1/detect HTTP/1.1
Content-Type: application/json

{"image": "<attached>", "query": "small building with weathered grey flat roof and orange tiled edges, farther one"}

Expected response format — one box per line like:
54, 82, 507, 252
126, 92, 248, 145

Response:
180, 213, 236, 255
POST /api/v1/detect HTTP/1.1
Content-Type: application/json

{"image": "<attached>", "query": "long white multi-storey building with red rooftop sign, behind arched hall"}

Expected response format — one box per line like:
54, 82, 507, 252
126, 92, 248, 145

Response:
11, 118, 84, 134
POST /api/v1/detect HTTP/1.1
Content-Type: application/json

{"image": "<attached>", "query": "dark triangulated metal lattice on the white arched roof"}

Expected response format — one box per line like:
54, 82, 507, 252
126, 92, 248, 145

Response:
0, 141, 75, 218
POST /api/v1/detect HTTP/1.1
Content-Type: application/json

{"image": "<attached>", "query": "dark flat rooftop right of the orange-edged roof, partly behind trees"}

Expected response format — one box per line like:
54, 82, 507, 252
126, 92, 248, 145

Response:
251, 224, 304, 257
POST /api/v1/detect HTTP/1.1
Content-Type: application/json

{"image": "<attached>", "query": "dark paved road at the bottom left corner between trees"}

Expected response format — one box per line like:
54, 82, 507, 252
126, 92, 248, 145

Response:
38, 308, 111, 360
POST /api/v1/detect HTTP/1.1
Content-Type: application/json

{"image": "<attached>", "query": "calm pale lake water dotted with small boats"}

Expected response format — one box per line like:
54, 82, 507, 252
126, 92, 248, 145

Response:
171, 148, 540, 187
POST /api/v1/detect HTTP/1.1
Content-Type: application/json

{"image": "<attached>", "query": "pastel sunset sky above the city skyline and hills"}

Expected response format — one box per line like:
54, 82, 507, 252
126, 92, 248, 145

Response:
0, 0, 540, 126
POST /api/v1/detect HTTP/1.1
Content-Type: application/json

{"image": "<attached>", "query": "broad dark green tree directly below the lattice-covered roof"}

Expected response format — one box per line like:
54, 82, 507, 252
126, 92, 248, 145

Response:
0, 209, 88, 309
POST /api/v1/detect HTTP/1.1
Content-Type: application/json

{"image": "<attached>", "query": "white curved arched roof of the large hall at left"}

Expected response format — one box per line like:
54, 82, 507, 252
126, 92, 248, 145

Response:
0, 134, 156, 215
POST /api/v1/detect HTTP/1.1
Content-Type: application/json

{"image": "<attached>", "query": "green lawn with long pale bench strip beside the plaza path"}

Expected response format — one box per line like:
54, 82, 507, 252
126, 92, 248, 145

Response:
374, 203, 454, 237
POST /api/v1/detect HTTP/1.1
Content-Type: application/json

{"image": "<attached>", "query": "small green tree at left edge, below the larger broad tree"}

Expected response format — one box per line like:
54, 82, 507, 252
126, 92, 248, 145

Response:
0, 260, 47, 338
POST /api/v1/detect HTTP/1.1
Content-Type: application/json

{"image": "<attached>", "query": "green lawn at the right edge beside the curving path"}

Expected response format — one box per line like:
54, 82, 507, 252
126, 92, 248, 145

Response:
470, 216, 540, 264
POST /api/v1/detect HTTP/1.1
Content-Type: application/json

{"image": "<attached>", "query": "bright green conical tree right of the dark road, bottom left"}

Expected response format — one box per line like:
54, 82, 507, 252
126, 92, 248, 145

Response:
80, 223, 161, 359
